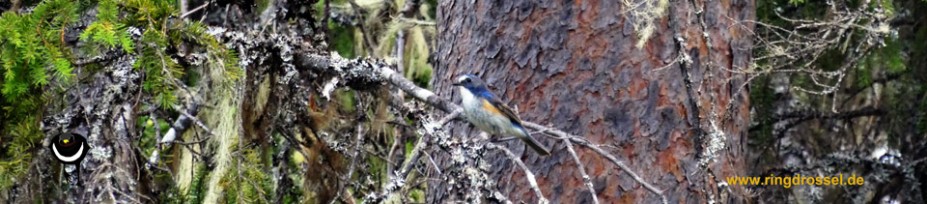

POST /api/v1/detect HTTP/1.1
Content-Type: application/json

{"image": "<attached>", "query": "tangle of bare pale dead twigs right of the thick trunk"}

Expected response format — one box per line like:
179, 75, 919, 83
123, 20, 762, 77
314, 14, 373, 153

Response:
748, 1, 896, 97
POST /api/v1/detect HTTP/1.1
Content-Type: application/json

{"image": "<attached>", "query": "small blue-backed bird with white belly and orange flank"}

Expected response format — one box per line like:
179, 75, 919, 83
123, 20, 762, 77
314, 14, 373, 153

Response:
453, 74, 550, 155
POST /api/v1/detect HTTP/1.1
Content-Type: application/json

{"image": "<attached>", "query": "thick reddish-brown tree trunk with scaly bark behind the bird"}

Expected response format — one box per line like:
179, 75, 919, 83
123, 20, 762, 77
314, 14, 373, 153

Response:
428, 0, 754, 203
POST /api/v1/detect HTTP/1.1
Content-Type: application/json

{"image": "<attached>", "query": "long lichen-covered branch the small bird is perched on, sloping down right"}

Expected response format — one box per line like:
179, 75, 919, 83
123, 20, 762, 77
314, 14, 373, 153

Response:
296, 53, 667, 203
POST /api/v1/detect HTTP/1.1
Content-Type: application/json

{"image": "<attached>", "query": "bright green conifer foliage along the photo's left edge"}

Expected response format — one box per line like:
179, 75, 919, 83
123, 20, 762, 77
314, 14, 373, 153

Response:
0, 0, 78, 189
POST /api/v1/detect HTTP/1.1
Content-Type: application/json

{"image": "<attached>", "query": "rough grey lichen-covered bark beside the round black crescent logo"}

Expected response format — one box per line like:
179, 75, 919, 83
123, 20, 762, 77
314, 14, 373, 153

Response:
43, 53, 145, 203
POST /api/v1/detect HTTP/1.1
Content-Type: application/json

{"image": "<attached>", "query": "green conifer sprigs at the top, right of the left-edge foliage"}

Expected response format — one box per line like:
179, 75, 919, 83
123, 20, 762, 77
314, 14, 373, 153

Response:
81, 0, 241, 108
